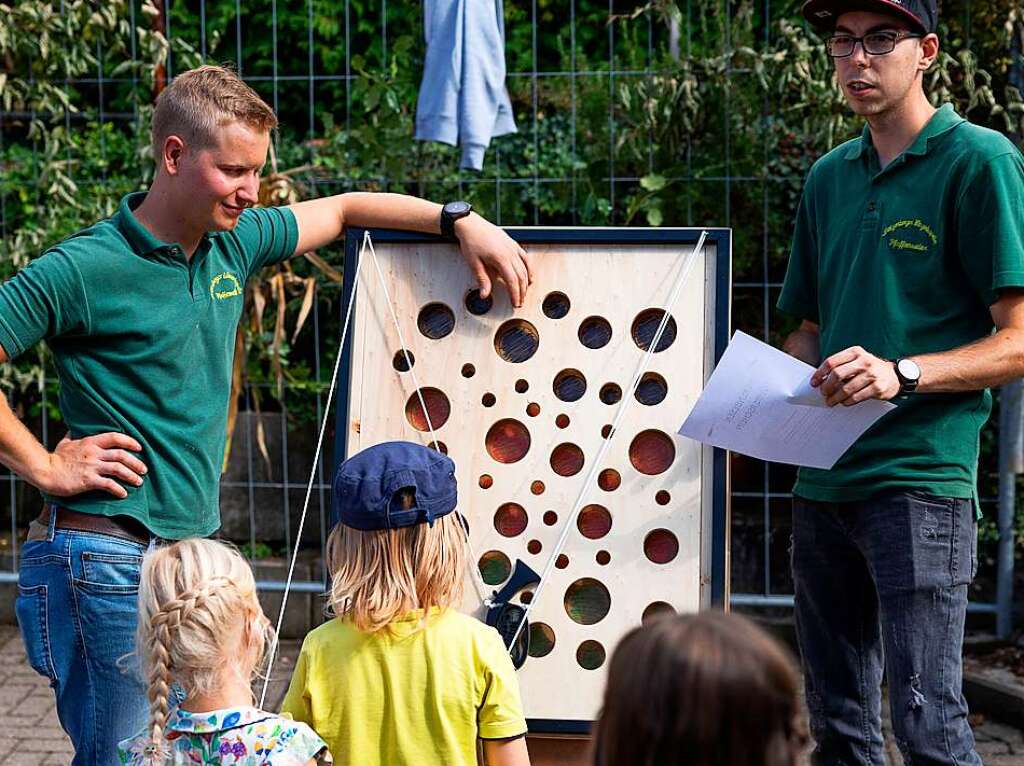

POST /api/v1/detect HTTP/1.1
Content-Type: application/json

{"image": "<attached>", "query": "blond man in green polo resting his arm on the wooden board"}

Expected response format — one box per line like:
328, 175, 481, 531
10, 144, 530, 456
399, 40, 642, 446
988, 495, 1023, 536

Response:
0, 67, 530, 766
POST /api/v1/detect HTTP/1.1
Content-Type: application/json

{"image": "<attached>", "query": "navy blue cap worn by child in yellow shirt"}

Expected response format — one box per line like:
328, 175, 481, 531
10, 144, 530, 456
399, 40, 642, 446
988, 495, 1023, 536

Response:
331, 441, 459, 529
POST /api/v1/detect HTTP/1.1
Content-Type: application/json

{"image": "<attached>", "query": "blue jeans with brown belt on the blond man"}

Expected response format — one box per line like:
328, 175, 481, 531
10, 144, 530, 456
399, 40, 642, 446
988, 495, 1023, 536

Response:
15, 507, 148, 766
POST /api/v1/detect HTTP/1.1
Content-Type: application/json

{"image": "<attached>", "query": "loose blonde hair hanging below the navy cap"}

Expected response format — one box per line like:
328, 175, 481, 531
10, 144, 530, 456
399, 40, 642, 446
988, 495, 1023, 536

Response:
327, 513, 468, 633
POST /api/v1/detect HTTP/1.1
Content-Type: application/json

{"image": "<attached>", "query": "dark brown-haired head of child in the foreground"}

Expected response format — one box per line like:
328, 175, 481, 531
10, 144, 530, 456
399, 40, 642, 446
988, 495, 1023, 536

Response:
594, 611, 807, 766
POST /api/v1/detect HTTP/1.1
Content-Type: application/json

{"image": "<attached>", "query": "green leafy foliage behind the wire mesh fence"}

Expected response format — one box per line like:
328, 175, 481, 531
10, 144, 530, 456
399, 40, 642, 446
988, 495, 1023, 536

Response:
0, 0, 1024, 565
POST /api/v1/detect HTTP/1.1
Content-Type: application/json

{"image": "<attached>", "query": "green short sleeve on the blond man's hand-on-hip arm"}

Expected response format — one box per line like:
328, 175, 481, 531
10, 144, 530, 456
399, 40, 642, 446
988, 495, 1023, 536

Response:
0, 249, 89, 359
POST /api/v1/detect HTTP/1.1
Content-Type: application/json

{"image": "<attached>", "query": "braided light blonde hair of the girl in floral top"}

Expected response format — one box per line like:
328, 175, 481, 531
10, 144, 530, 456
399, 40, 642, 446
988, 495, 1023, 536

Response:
135, 538, 273, 765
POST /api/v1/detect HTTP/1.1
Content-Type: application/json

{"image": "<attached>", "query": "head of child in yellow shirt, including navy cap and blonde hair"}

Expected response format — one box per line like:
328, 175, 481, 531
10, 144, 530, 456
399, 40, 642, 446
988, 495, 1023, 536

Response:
327, 441, 467, 633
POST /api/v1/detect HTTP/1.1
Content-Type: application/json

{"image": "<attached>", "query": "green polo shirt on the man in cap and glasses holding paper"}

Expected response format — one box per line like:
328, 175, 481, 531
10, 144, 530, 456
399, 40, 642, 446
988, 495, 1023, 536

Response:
778, 105, 1024, 502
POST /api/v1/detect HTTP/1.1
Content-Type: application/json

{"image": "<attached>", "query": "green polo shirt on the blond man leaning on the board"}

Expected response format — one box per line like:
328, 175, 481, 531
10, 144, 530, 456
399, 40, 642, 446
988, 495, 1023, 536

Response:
0, 193, 298, 539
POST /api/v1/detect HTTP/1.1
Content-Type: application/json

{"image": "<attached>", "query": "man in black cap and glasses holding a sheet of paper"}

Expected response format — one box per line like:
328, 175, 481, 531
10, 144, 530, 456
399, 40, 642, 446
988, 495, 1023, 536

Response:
778, 0, 1024, 766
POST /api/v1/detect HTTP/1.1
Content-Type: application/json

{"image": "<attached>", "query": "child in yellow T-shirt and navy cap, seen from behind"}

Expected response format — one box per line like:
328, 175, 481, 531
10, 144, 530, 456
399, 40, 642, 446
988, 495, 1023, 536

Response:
283, 441, 529, 766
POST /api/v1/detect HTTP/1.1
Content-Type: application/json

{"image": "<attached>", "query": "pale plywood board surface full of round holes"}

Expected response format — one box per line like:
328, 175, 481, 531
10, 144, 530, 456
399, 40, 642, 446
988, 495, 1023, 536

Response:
347, 237, 714, 725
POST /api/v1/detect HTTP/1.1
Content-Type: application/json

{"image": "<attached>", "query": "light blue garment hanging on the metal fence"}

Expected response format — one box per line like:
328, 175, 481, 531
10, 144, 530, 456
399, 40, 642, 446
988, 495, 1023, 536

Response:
416, 0, 516, 170
